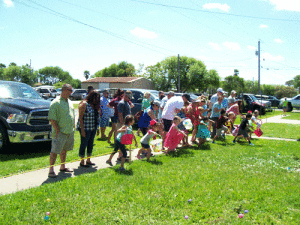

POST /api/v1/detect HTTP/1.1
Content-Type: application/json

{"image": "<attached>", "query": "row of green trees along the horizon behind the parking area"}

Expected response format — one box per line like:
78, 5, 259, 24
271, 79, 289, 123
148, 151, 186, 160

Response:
0, 56, 300, 98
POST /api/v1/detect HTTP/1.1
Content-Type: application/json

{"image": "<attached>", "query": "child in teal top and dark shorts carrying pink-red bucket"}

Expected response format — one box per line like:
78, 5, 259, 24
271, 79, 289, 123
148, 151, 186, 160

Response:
106, 115, 138, 171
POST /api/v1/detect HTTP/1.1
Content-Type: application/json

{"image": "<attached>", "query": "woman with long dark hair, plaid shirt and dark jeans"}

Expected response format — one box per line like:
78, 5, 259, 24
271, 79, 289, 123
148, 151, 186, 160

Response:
77, 91, 103, 167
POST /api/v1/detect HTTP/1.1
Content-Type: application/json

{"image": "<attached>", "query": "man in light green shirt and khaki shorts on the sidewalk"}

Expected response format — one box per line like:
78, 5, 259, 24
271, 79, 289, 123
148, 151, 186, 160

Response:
48, 84, 75, 178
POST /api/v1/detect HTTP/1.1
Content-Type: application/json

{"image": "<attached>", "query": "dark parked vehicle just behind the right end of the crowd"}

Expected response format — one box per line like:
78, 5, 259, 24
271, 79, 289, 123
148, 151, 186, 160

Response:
238, 93, 271, 115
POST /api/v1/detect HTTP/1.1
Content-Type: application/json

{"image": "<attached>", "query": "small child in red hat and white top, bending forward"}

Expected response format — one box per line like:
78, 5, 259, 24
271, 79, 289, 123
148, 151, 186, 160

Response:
136, 120, 160, 162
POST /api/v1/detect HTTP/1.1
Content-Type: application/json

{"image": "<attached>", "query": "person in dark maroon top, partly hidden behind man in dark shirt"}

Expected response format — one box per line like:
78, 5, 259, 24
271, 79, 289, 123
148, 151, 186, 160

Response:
107, 89, 125, 143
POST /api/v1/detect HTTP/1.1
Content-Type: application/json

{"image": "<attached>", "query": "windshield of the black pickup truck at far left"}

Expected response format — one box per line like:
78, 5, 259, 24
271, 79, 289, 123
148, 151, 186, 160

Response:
0, 83, 41, 99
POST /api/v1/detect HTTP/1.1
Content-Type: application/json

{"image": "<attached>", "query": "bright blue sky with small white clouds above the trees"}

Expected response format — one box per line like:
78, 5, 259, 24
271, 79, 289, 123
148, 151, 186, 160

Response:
0, 0, 300, 84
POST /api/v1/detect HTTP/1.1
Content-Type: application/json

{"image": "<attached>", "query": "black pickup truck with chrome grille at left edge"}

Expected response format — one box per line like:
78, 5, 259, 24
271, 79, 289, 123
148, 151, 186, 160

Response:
0, 81, 51, 152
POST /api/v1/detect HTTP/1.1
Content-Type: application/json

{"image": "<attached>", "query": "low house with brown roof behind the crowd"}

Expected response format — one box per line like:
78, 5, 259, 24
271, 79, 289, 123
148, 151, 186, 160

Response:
81, 77, 154, 89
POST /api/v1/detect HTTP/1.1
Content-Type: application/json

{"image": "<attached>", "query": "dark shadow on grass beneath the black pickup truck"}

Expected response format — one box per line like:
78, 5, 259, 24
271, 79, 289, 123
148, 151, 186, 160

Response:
0, 141, 51, 162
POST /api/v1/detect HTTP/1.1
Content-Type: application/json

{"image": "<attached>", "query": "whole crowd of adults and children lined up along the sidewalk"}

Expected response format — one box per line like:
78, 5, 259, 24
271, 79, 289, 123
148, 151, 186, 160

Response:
48, 84, 258, 178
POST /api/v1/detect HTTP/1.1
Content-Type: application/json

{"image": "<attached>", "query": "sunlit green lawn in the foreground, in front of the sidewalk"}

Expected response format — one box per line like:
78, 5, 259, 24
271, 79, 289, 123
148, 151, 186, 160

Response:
0, 137, 300, 224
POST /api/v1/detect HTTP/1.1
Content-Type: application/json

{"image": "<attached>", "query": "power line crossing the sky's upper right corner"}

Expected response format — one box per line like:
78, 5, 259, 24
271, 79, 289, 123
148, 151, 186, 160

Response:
130, 0, 300, 22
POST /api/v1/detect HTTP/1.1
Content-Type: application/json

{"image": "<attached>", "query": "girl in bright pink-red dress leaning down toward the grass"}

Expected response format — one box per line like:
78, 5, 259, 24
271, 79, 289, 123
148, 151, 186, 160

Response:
164, 116, 187, 154
